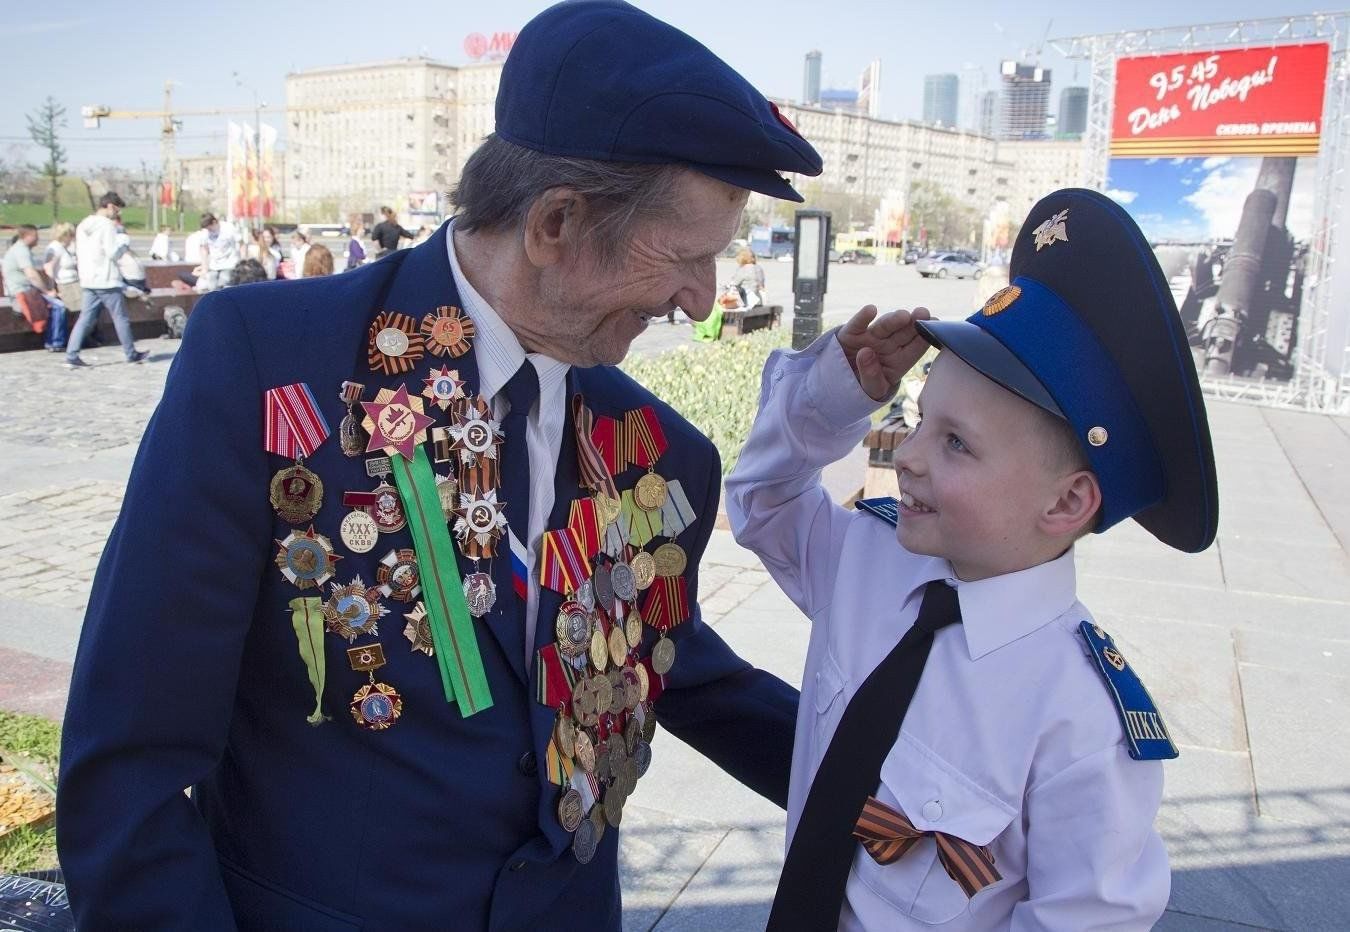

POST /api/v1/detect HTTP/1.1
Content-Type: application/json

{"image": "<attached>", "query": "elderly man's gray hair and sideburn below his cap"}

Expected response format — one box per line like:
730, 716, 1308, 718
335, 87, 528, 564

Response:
450, 134, 687, 267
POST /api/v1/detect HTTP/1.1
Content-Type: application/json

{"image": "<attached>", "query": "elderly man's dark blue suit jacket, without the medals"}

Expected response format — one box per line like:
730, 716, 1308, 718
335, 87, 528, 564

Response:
57, 227, 797, 932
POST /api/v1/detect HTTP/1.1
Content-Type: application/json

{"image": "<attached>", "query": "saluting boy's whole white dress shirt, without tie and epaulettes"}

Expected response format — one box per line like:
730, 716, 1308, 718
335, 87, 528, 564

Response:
726, 332, 1170, 932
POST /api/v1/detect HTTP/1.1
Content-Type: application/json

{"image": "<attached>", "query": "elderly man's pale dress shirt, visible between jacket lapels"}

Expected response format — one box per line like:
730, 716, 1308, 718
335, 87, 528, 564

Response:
446, 222, 570, 670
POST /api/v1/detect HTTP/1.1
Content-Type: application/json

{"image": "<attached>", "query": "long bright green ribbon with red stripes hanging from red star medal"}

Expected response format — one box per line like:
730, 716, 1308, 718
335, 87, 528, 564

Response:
390, 447, 493, 717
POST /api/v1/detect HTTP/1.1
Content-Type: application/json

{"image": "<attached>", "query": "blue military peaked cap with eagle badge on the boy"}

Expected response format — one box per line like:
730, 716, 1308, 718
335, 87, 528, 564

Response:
919, 188, 1219, 552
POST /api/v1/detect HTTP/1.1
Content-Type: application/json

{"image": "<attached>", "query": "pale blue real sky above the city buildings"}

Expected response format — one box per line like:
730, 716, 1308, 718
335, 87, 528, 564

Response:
0, 0, 1324, 167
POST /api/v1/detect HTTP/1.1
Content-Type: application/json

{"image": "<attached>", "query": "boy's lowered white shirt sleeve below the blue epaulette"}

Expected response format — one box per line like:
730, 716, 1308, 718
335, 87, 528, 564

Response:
1010, 746, 1172, 932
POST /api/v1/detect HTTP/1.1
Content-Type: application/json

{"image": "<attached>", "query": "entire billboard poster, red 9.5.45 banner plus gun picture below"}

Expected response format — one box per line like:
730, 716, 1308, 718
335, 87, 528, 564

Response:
1107, 43, 1330, 381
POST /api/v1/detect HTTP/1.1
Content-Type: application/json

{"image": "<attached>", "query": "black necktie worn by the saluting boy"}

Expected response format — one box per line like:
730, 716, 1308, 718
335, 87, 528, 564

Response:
768, 579, 961, 932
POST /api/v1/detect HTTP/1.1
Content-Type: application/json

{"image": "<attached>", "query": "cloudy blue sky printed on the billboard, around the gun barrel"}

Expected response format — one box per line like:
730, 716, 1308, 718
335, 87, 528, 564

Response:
1107, 155, 1316, 242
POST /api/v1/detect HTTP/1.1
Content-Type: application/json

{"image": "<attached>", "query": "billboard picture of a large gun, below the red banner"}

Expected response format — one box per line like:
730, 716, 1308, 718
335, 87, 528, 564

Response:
1107, 155, 1316, 381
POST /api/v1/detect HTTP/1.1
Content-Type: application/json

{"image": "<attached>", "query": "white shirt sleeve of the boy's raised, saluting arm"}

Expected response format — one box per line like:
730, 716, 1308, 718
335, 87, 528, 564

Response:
726, 331, 880, 616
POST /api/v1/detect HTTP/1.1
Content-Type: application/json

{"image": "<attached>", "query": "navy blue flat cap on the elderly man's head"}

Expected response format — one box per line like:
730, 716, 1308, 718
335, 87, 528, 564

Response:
495, 0, 821, 201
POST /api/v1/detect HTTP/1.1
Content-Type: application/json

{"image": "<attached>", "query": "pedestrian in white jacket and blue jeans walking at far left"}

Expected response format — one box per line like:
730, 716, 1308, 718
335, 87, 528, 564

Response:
66, 190, 150, 369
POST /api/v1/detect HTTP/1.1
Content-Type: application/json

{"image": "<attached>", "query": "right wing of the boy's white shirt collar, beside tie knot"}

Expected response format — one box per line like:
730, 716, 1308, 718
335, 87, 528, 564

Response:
937, 547, 1077, 661
